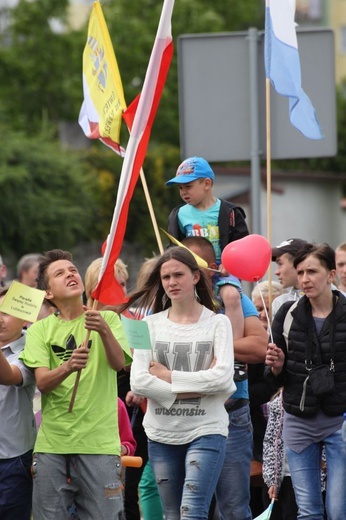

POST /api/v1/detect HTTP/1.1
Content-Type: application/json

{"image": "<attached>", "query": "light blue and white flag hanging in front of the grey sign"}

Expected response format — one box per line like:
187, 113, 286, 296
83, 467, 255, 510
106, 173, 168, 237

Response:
264, 0, 323, 139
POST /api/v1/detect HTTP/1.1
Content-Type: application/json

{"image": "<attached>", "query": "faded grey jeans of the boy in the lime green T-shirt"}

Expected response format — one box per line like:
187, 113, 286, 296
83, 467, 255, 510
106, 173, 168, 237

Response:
33, 453, 123, 520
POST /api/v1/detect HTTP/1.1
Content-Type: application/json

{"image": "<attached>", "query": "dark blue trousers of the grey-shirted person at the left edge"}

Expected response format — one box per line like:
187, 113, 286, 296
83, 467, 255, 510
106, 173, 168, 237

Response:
0, 451, 32, 520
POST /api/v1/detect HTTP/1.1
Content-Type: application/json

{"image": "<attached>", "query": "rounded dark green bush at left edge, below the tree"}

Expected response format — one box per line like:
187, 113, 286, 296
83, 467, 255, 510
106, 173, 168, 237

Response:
0, 124, 97, 257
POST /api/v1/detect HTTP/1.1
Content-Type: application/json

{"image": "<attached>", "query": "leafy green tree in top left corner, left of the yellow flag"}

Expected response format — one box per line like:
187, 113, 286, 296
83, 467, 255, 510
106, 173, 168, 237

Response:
0, 0, 85, 132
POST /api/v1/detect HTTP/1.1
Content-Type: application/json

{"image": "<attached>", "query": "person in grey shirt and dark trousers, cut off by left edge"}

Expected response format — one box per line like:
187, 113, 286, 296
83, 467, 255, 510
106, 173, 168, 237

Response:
0, 287, 36, 520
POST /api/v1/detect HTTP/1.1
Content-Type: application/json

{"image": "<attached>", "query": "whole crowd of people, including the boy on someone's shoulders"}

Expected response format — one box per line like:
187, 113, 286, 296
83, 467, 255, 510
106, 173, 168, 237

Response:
0, 157, 346, 520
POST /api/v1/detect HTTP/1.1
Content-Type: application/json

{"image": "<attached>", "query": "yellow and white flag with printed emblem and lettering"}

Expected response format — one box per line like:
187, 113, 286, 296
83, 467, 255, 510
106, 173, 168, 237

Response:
78, 1, 126, 155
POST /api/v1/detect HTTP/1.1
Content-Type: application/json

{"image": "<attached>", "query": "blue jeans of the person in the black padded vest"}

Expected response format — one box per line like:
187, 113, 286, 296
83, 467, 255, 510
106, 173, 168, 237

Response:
286, 429, 346, 520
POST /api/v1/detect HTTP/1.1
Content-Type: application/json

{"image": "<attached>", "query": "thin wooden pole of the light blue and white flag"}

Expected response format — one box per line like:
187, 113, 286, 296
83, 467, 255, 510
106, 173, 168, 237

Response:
266, 78, 273, 323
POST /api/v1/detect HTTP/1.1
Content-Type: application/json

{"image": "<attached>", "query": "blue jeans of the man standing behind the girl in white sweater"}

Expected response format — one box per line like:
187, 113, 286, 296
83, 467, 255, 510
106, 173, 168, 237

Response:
216, 405, 253, 520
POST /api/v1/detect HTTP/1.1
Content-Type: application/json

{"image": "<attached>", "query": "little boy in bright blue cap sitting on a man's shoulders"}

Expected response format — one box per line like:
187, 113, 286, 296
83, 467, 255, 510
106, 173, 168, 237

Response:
166, 157, 249, 339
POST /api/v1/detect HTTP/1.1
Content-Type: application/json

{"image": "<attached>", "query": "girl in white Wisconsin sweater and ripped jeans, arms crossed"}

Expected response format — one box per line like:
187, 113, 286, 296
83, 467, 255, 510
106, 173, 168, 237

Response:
120, 247, 235, 520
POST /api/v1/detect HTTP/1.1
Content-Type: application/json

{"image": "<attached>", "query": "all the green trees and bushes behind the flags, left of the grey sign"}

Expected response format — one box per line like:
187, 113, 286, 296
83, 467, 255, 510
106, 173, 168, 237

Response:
0, 0, 264, 256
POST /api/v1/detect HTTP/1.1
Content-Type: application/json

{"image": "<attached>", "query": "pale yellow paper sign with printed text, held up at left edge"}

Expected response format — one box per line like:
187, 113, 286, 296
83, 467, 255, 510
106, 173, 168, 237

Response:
0, 281, 45, 323
